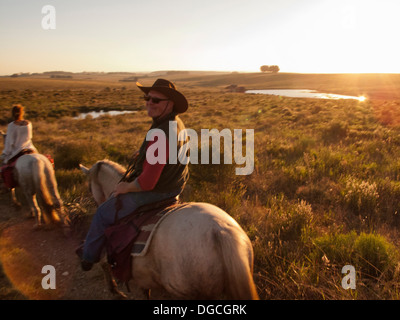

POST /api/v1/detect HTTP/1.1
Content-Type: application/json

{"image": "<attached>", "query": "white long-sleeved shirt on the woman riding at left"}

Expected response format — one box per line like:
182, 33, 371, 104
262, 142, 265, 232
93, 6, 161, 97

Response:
2, 121, 37, 163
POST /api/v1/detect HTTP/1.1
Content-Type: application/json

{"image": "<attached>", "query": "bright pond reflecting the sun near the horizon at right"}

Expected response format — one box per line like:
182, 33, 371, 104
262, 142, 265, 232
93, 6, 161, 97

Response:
246, 89, 365, 101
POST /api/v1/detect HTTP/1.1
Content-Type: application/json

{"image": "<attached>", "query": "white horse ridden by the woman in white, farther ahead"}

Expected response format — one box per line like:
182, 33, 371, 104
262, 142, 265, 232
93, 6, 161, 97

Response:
13, 153, 65, 227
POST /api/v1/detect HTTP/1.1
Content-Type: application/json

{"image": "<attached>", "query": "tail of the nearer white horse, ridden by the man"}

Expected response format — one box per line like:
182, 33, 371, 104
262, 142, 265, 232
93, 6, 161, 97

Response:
214, 229, 259, 300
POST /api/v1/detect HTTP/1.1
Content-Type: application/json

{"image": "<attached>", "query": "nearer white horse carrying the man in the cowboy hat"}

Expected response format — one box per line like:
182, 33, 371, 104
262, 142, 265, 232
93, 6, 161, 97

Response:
80, 160, 258, 299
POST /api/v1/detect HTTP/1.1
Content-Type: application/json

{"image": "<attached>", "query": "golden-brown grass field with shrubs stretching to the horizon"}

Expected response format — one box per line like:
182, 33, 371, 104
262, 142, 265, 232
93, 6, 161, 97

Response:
0, 73, 400, 299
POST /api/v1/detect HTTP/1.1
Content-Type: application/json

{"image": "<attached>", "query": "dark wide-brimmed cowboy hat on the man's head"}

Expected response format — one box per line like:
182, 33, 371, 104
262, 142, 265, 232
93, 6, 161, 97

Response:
136, 79, 188, 113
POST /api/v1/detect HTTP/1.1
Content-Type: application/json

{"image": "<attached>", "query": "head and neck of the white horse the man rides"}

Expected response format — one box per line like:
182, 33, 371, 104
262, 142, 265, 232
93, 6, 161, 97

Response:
79, 160, 125, 205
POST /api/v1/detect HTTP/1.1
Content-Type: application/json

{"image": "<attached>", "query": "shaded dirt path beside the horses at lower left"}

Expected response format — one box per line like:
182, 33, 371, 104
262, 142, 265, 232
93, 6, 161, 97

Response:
0, 194, 145, 300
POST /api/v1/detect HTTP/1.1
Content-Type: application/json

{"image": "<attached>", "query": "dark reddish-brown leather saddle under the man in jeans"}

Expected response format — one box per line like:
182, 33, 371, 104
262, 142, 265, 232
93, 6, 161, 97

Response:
105, 197, 182, 282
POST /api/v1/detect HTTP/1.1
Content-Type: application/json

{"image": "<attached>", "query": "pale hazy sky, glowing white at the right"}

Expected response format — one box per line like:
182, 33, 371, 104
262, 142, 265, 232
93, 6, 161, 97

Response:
0, 0, 400, 75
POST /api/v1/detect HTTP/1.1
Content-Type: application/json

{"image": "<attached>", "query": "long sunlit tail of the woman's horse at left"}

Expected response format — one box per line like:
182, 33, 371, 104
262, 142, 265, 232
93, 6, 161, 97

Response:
32, 159, 63, 223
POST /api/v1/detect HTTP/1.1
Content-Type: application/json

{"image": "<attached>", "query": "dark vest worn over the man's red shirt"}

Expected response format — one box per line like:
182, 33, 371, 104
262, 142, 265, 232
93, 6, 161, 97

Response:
123, 113, 189, 193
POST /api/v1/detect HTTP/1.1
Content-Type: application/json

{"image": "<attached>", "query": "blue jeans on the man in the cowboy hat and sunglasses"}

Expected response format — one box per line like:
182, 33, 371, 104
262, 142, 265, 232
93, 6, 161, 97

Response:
82, 191, 180, 263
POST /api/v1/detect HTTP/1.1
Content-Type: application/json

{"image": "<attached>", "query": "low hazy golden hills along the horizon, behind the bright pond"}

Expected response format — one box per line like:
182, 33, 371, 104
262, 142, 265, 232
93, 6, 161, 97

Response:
0, 70, 400, 100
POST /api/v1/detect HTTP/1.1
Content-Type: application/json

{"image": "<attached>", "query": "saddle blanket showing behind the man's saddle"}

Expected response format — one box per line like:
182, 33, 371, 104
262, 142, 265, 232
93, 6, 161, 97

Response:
131, 203, 186, 257
